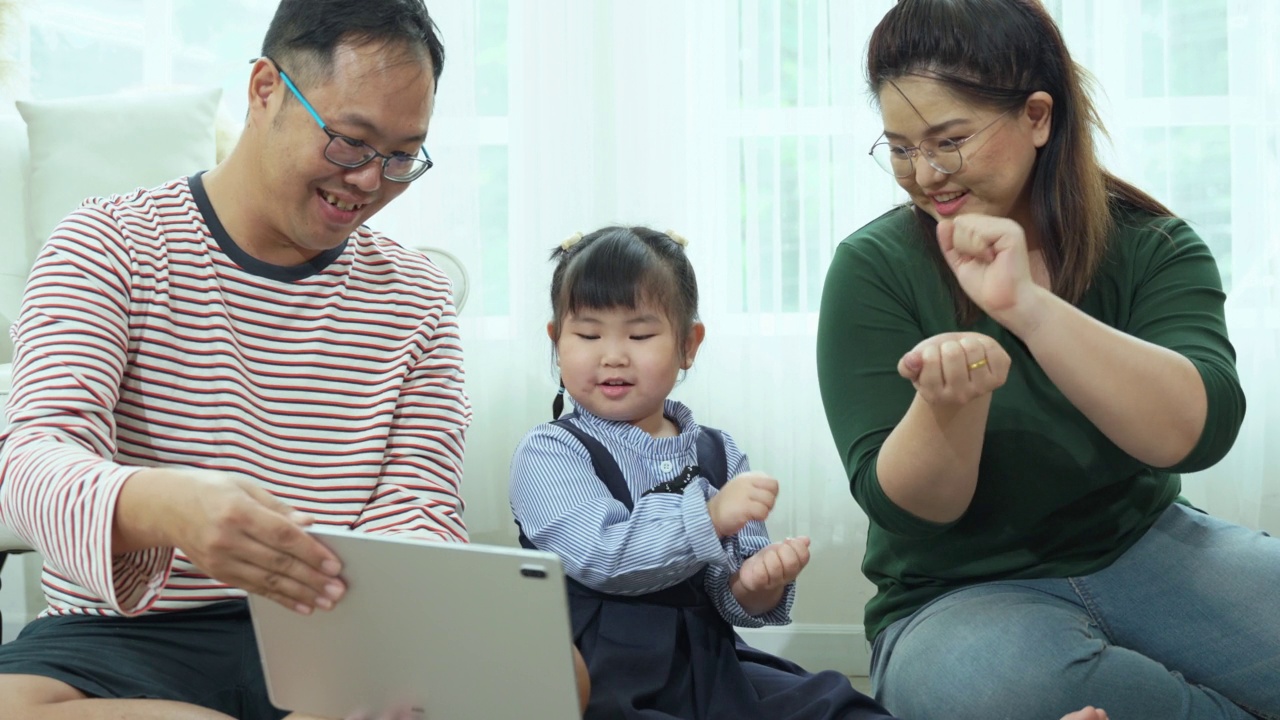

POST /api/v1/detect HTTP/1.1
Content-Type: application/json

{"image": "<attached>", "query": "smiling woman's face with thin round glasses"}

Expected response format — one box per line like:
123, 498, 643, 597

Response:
879, 76, 1052, 235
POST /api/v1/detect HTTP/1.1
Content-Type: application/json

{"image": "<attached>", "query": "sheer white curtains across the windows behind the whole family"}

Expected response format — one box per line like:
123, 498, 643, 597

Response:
17, 0, 1280, 671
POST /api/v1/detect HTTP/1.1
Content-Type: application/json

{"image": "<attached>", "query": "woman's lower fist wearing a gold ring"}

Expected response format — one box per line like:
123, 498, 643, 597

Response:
897, 333, 1011, 406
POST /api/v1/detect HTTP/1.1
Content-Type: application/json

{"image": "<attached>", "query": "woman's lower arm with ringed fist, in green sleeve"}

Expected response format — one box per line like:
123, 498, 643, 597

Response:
818, 228, 1009, 527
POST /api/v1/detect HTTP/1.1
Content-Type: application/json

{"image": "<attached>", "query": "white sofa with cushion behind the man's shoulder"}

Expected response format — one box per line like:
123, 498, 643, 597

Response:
0, 88, 222, 630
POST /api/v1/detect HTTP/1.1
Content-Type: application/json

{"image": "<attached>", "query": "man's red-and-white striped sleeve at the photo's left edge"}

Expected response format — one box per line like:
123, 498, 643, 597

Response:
0, 206, 173, 615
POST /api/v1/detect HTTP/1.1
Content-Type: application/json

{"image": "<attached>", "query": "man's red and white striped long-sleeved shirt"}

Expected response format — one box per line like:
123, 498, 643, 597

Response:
0, 176, 471, 615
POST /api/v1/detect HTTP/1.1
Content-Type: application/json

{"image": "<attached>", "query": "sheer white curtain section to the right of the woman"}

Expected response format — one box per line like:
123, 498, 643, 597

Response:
1055, 0, 1280, 533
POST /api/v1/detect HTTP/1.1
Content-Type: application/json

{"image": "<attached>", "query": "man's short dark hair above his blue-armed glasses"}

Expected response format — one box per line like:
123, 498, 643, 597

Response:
262, 0, 444, 86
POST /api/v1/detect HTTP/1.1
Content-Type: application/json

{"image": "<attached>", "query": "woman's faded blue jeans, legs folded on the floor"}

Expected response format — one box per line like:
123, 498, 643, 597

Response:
872, 505, 1280, 720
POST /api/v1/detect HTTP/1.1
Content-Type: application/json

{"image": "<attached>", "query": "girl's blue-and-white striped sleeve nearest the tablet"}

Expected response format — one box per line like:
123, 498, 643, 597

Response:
511, 425, 728, 596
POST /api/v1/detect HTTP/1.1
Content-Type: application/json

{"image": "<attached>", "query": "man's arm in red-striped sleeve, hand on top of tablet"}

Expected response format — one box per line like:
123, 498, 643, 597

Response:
0, 206, 343, 615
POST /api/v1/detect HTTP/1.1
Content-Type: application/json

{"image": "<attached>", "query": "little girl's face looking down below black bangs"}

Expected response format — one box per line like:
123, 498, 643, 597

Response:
547, 299, 705, 437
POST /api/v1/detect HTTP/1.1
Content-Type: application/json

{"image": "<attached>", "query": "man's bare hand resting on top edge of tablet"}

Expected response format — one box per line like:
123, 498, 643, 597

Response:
113, 468, 346, 614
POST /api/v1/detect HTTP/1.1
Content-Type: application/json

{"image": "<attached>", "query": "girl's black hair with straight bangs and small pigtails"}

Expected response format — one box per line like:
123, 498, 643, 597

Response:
550, 227, 698, 418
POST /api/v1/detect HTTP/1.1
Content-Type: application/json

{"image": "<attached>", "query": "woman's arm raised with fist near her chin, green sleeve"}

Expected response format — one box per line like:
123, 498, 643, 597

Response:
938, 215, 1243, 468
